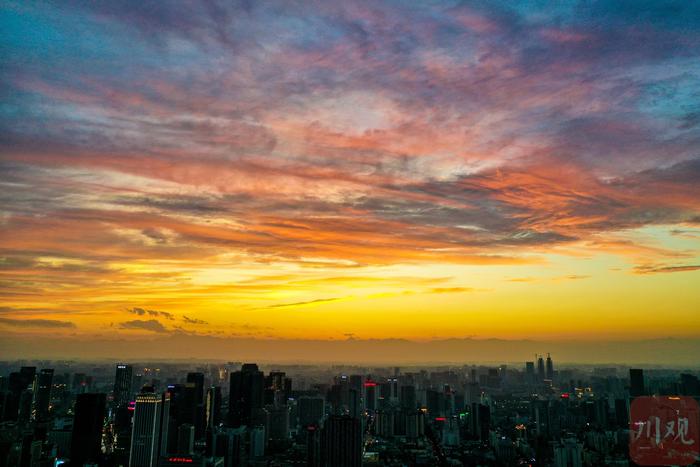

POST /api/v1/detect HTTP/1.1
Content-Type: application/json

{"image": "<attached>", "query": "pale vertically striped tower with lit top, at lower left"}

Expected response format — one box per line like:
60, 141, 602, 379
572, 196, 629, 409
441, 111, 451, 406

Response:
129, 392, 170, 467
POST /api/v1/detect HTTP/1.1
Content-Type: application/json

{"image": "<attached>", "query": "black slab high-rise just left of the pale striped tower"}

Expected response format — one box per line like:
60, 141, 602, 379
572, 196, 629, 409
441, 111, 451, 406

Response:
70, 393, 107, 465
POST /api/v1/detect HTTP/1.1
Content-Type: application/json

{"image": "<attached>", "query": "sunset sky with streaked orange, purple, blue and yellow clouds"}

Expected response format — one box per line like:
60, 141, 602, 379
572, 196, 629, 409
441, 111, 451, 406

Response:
0, 0, 700, 359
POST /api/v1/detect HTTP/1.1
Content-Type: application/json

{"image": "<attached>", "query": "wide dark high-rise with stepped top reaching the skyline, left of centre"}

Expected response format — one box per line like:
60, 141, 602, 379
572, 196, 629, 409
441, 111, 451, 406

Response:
229, 363, 265, 427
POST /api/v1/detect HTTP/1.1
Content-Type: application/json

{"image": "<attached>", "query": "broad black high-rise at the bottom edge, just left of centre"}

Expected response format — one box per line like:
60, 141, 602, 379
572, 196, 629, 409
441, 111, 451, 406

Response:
321, 415, 362, 467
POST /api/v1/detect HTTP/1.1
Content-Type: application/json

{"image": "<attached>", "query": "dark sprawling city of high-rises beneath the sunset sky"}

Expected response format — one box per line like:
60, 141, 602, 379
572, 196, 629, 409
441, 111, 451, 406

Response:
0, 354, 700, 467
